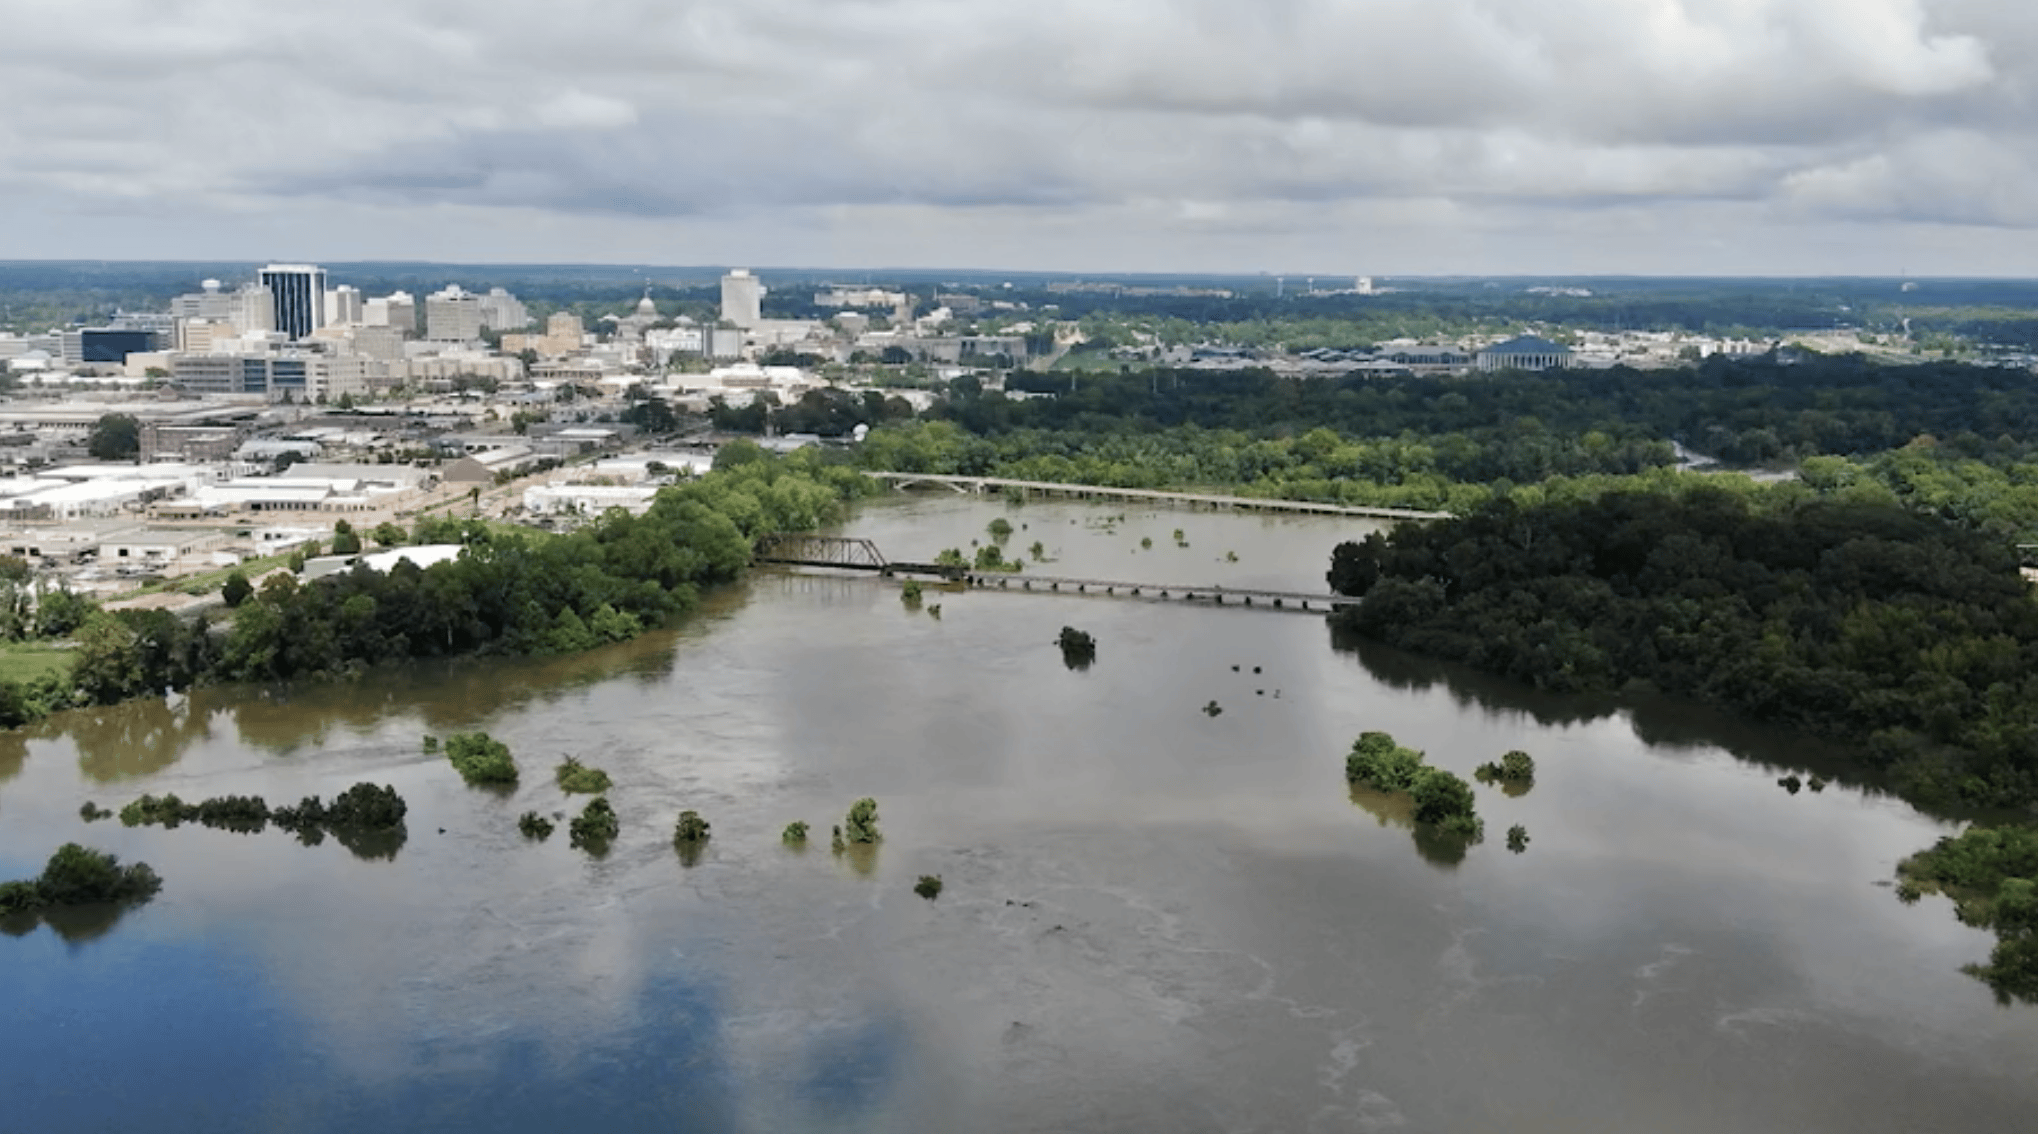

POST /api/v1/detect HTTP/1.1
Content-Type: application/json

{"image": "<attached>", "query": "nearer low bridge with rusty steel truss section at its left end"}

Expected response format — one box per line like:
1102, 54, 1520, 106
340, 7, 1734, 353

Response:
752, 532, 1359, 612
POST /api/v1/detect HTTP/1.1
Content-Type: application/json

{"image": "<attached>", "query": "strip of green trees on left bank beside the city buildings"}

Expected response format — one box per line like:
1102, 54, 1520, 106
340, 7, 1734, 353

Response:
0, 445, 876, 726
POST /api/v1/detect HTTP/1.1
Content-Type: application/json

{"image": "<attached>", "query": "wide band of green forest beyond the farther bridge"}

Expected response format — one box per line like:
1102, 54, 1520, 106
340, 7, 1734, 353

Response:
827, 359, 2038, 543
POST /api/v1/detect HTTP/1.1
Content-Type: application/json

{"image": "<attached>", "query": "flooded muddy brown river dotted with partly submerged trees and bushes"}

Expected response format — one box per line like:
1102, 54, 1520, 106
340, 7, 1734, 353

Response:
0, 498, 2038, 1134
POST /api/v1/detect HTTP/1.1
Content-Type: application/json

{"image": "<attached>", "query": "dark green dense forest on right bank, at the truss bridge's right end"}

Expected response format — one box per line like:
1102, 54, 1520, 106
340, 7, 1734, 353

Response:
1329, 491, 2038, 806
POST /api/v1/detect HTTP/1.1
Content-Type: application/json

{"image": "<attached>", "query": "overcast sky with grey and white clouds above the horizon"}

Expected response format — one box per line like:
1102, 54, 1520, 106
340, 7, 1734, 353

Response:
0, 0, 2038, 275
